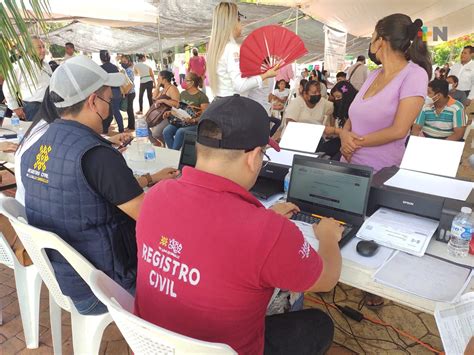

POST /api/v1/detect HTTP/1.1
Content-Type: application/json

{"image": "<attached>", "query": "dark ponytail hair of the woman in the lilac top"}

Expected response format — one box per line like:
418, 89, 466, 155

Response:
375, 14, 432, 80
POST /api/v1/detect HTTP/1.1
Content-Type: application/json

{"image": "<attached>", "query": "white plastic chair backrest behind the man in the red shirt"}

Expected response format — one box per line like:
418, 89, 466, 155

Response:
89, 270, 237, 355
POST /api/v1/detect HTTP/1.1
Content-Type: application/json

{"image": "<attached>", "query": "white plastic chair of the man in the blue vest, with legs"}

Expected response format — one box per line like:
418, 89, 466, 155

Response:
0, 198, 112, 355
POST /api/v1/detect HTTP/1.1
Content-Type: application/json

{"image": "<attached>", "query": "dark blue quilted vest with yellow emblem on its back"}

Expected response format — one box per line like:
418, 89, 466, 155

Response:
21, 120, 137, 301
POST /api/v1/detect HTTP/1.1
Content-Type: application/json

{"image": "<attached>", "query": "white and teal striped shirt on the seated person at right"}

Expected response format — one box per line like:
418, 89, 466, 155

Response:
415, 97, 467, 138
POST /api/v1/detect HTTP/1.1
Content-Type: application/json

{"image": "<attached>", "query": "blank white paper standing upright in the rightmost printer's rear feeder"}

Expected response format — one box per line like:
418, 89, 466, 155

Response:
400, 136, 464, 177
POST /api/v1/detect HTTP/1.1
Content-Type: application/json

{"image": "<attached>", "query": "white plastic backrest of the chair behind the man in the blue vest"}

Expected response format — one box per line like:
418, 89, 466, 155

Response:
0, 198, 94, 312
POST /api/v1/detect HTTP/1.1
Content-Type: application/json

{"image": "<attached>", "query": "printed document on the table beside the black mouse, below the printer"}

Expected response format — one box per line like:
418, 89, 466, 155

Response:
357, 208, 439, 256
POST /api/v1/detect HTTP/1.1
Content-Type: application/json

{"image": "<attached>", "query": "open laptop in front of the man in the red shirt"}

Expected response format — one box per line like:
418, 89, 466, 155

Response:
287, 155, 373, 247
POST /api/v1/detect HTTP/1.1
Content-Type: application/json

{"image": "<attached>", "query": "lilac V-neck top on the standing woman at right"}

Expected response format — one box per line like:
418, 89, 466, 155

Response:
342, 62, 428, 172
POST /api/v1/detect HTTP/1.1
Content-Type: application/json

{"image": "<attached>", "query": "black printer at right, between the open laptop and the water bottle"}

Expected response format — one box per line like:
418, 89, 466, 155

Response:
367, 167, 474, 243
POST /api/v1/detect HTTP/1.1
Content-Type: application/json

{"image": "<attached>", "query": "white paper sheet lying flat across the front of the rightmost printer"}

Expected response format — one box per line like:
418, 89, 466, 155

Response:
385, 169, 474, 201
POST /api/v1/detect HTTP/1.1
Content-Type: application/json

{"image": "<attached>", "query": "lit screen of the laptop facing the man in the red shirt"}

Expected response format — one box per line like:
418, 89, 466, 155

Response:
288, 157, 372, 216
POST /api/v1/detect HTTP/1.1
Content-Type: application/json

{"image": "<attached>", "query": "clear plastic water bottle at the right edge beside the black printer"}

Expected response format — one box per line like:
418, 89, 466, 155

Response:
448, 207, 474, 258
